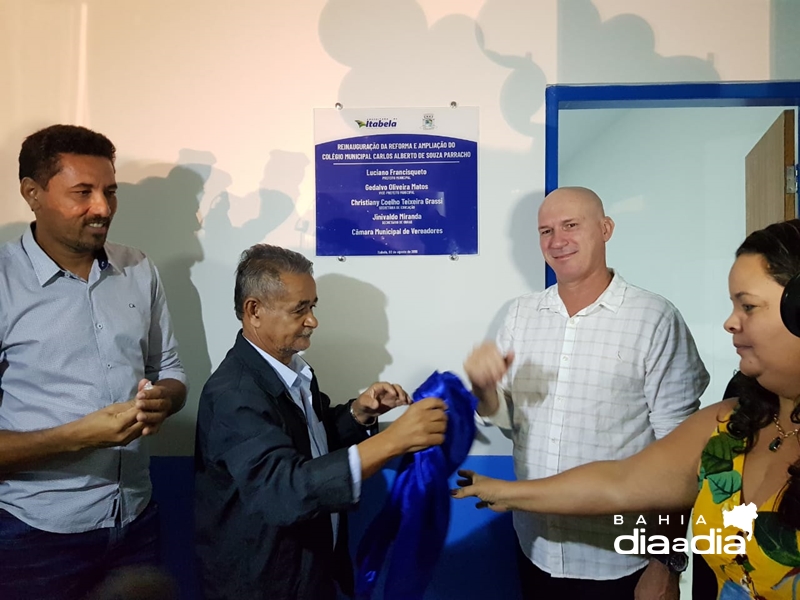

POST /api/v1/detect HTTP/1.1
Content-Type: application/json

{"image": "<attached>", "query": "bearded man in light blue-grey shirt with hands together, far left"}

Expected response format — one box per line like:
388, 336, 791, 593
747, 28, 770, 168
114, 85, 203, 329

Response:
0, 125, 186, 600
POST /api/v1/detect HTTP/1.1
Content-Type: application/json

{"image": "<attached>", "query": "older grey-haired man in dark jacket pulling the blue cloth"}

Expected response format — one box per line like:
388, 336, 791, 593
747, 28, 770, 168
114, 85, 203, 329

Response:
195, 244, 447, 600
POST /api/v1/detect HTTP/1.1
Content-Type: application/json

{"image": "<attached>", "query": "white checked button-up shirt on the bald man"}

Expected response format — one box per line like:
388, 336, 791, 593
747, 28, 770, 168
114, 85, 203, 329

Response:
497, 274, 709, 579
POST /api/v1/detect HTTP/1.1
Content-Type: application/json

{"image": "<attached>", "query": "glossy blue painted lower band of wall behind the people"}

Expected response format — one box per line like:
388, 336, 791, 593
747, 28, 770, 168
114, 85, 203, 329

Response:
150, 456, 519, 600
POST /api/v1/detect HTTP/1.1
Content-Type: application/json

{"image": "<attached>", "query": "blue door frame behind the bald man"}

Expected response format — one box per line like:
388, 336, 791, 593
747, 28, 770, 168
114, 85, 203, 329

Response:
544, 81, 800, 286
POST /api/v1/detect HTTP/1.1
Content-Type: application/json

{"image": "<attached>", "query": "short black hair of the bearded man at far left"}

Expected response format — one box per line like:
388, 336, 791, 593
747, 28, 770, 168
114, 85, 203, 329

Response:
19, 125, 117, 188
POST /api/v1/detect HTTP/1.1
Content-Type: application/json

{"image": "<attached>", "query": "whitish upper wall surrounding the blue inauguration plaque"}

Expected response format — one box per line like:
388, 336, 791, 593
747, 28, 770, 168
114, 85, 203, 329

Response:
0, 0, 800, 454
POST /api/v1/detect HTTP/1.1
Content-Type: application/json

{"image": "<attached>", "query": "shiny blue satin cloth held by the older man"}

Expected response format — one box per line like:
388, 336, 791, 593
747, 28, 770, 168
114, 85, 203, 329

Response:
356, 371, 478, 600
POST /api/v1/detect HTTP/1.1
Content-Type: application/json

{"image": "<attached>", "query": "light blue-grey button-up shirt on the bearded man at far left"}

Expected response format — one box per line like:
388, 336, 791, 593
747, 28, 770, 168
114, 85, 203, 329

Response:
0, 228, 186, 533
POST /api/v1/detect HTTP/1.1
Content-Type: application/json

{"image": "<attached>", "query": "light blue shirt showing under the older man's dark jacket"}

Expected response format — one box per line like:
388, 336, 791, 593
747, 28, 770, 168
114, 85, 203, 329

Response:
245, 338, 361, 546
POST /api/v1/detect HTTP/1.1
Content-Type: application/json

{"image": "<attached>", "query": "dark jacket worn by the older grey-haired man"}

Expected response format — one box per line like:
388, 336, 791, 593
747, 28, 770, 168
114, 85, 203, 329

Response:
195, 331, 367, 600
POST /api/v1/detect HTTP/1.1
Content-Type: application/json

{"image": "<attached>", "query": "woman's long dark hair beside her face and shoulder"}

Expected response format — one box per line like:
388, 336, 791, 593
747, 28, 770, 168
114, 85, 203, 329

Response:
725, 219, 800, 529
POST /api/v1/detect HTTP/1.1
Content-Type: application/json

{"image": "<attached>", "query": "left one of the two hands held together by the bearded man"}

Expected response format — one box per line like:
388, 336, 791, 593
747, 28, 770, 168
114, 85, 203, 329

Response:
67, 400, 145, 450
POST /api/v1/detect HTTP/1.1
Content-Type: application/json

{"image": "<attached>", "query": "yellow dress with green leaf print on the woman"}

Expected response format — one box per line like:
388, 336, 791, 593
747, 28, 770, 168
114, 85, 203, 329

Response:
692, 420, 800, 600
